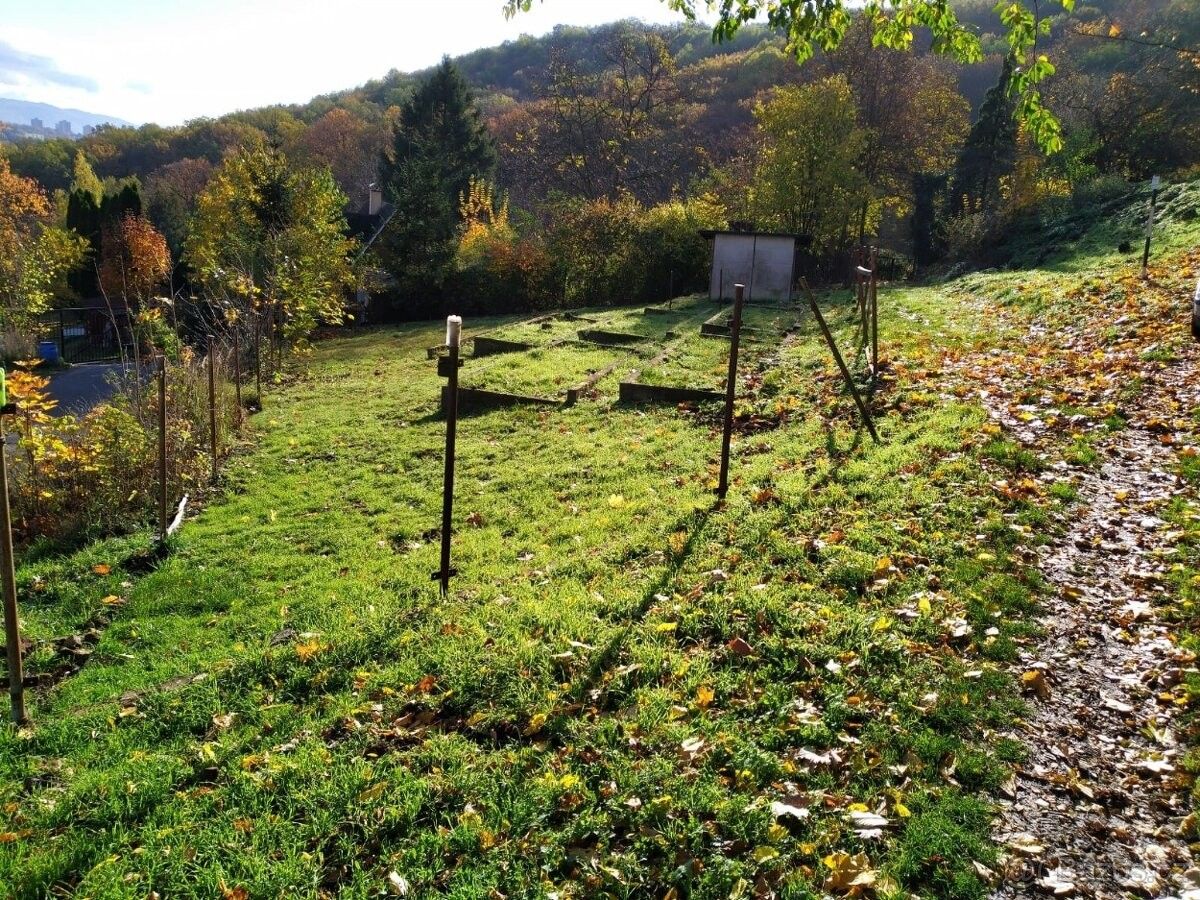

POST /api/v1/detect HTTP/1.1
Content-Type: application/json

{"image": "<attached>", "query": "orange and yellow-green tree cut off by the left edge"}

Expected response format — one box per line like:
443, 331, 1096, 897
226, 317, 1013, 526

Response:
0, 157, 83, 330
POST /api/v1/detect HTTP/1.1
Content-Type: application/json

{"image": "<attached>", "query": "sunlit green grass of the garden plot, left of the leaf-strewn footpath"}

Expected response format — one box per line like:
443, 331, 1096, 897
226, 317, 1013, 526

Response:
11, 174, 1200, 898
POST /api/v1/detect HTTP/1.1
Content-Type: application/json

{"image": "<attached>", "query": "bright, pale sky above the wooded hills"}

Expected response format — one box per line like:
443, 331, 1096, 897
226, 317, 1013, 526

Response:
0, 0, 700, 125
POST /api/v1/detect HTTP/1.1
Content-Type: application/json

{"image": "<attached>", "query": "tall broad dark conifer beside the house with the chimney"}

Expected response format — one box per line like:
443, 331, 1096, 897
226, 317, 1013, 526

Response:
380, 58, 496, 314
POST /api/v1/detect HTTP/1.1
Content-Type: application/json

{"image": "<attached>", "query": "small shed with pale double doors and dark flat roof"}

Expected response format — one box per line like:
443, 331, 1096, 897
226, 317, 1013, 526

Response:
701, 230, 800, 301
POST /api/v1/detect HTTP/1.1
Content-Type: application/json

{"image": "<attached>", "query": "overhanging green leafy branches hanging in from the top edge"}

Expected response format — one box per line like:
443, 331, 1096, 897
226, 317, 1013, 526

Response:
504, 0, 1075, 152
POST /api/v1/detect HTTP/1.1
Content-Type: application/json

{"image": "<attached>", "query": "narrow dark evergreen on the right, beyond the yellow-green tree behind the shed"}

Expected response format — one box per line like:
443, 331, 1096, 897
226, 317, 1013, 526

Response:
950, 59, 1016, 214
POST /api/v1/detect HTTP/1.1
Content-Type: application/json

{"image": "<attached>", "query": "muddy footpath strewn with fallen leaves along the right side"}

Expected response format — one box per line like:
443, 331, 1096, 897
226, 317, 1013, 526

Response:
985, 338, 1200, 900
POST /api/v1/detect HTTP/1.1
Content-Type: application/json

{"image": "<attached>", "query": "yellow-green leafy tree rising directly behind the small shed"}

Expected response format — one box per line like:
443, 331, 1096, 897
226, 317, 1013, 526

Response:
749, 76, 870, 251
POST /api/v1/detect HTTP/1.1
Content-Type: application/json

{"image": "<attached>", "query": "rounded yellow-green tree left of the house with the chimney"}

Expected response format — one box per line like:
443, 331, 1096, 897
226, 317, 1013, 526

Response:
185, 146, 354, 343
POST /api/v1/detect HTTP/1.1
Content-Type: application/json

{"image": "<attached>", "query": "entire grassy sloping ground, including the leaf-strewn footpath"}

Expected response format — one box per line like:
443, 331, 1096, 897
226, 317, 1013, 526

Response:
0, 185, 1200, 899
